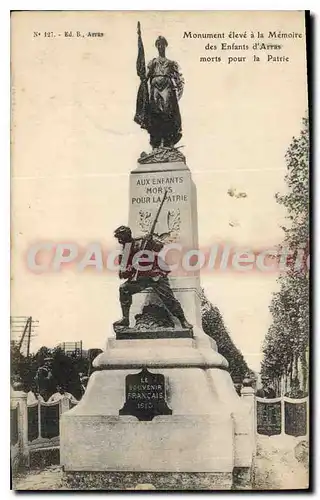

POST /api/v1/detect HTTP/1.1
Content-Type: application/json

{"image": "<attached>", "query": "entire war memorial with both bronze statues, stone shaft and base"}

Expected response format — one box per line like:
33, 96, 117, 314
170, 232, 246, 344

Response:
60, 25, 254, 490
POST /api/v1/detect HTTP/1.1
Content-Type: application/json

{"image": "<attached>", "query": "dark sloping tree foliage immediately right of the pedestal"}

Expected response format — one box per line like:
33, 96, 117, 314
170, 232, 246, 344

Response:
200, 289, 252, 383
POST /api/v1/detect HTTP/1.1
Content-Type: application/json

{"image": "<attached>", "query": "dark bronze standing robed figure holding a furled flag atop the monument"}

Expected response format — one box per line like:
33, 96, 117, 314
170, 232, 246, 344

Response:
134, 23, 184, 149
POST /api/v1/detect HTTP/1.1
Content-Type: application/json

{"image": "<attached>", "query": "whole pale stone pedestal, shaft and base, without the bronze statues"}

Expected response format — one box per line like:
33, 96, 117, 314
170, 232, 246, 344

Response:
60, 162, 253, 490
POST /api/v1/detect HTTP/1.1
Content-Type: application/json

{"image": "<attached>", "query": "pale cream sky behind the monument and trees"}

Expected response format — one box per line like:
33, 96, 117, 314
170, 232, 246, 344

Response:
11, 11, 307, 370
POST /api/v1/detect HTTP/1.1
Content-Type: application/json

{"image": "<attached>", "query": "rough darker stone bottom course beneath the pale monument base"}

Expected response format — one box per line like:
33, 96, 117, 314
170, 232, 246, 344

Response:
64, 472, 232, 491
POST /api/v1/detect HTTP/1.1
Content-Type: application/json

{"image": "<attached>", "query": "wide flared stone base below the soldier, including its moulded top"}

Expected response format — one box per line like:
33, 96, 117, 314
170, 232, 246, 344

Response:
60, 338, 252, 480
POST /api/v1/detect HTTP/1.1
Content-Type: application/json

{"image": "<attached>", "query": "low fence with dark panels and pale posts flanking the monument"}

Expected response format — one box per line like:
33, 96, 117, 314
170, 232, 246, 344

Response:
10, 387, 309, 466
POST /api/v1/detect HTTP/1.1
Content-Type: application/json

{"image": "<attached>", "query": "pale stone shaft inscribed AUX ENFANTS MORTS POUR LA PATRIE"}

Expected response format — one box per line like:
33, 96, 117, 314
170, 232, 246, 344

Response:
129, 161, 210, 345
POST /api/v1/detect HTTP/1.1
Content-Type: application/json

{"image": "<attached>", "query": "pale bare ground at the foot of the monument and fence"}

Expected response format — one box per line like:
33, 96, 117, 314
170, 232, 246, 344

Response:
13, 436, 308, 491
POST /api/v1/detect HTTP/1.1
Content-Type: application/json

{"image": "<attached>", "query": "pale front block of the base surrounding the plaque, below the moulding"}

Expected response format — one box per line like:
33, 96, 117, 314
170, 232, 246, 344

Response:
60, 368, 234, 473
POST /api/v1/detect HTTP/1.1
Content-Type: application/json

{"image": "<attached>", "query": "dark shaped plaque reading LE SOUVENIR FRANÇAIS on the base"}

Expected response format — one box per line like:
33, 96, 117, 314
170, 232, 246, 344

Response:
119, 368, 172, 421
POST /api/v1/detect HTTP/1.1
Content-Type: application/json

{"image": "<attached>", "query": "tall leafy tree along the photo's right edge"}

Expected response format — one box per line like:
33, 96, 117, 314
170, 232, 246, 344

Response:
261, 119, 309, 390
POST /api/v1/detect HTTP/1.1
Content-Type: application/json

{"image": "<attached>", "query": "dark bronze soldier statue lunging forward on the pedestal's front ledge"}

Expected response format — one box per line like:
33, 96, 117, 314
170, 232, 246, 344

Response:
114, 226, 192, 329
